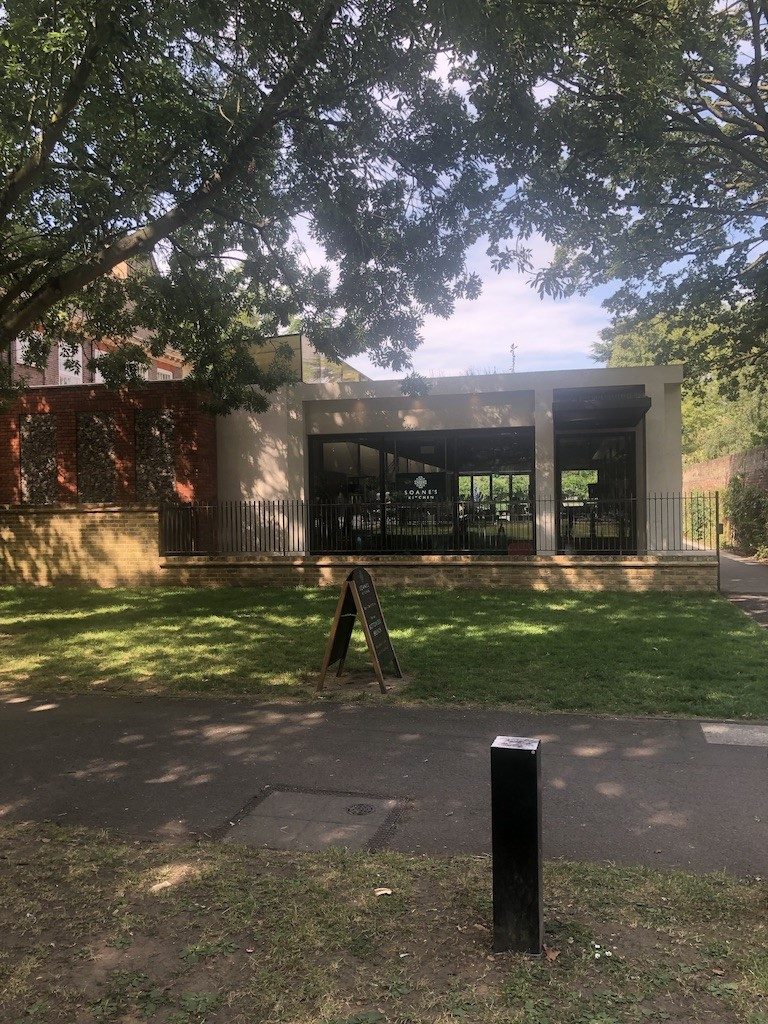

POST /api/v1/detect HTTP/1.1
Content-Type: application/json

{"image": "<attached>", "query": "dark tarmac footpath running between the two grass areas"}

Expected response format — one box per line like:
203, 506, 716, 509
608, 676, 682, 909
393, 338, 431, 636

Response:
0, 696, 768, 876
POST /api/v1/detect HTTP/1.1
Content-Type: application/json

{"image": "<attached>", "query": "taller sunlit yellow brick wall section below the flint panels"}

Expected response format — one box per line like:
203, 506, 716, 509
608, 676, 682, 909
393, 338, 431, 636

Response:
0, 506, 163, 587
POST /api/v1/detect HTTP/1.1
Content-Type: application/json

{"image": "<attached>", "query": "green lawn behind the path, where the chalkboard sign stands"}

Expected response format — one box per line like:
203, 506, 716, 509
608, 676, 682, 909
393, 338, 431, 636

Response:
0, 588, 768, 719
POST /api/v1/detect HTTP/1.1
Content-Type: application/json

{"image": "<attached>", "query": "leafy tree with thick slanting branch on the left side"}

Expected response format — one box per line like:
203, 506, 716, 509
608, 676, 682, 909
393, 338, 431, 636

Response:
0, 0, 570, 412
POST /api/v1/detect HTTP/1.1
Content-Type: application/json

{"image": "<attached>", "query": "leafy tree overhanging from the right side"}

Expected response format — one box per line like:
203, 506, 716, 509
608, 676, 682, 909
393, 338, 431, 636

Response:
493, 0, 768, 394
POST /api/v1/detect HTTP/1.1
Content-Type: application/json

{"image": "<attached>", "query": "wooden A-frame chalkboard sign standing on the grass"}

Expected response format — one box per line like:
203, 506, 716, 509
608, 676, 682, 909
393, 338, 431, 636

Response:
317, 566, 402, 693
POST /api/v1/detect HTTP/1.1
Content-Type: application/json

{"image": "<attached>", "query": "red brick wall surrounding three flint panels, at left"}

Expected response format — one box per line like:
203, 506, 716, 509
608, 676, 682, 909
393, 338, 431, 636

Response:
0, 381, 216, 505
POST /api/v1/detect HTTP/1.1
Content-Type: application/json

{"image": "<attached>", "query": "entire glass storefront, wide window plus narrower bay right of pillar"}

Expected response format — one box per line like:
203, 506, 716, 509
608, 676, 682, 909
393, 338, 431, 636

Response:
309, 428, 638, 554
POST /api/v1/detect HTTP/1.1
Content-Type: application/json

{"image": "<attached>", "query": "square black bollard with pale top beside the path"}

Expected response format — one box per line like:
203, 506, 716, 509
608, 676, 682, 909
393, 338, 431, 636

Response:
490, 736, 544, 953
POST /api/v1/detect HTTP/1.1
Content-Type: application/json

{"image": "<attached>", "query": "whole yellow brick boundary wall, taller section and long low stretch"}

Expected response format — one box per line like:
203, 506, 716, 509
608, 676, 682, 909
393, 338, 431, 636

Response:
0, 505, 718, 592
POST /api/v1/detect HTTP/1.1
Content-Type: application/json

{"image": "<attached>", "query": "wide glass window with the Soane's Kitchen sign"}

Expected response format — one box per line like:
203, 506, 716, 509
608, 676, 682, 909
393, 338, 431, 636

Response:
309, 428, 534, 552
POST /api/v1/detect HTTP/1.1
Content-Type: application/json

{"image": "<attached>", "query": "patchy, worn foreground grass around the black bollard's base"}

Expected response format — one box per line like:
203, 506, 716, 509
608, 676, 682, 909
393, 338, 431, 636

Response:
0, 825, 768, 1024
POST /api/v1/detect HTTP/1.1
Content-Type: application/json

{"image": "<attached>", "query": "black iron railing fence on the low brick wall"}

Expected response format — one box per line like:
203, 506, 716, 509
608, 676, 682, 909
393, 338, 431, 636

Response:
160, 494, 719, 556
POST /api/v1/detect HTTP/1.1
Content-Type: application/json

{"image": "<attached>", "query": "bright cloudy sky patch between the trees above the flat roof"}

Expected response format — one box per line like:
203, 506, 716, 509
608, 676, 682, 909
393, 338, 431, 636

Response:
349, 240, 608, 378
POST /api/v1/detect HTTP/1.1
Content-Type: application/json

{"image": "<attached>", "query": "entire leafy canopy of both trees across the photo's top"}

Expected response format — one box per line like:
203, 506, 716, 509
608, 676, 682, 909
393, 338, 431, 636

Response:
6, 0, 768, 411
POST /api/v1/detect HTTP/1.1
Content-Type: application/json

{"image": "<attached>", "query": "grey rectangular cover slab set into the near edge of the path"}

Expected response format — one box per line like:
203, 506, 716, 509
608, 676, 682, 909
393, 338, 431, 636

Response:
224, 790, 397, 850
